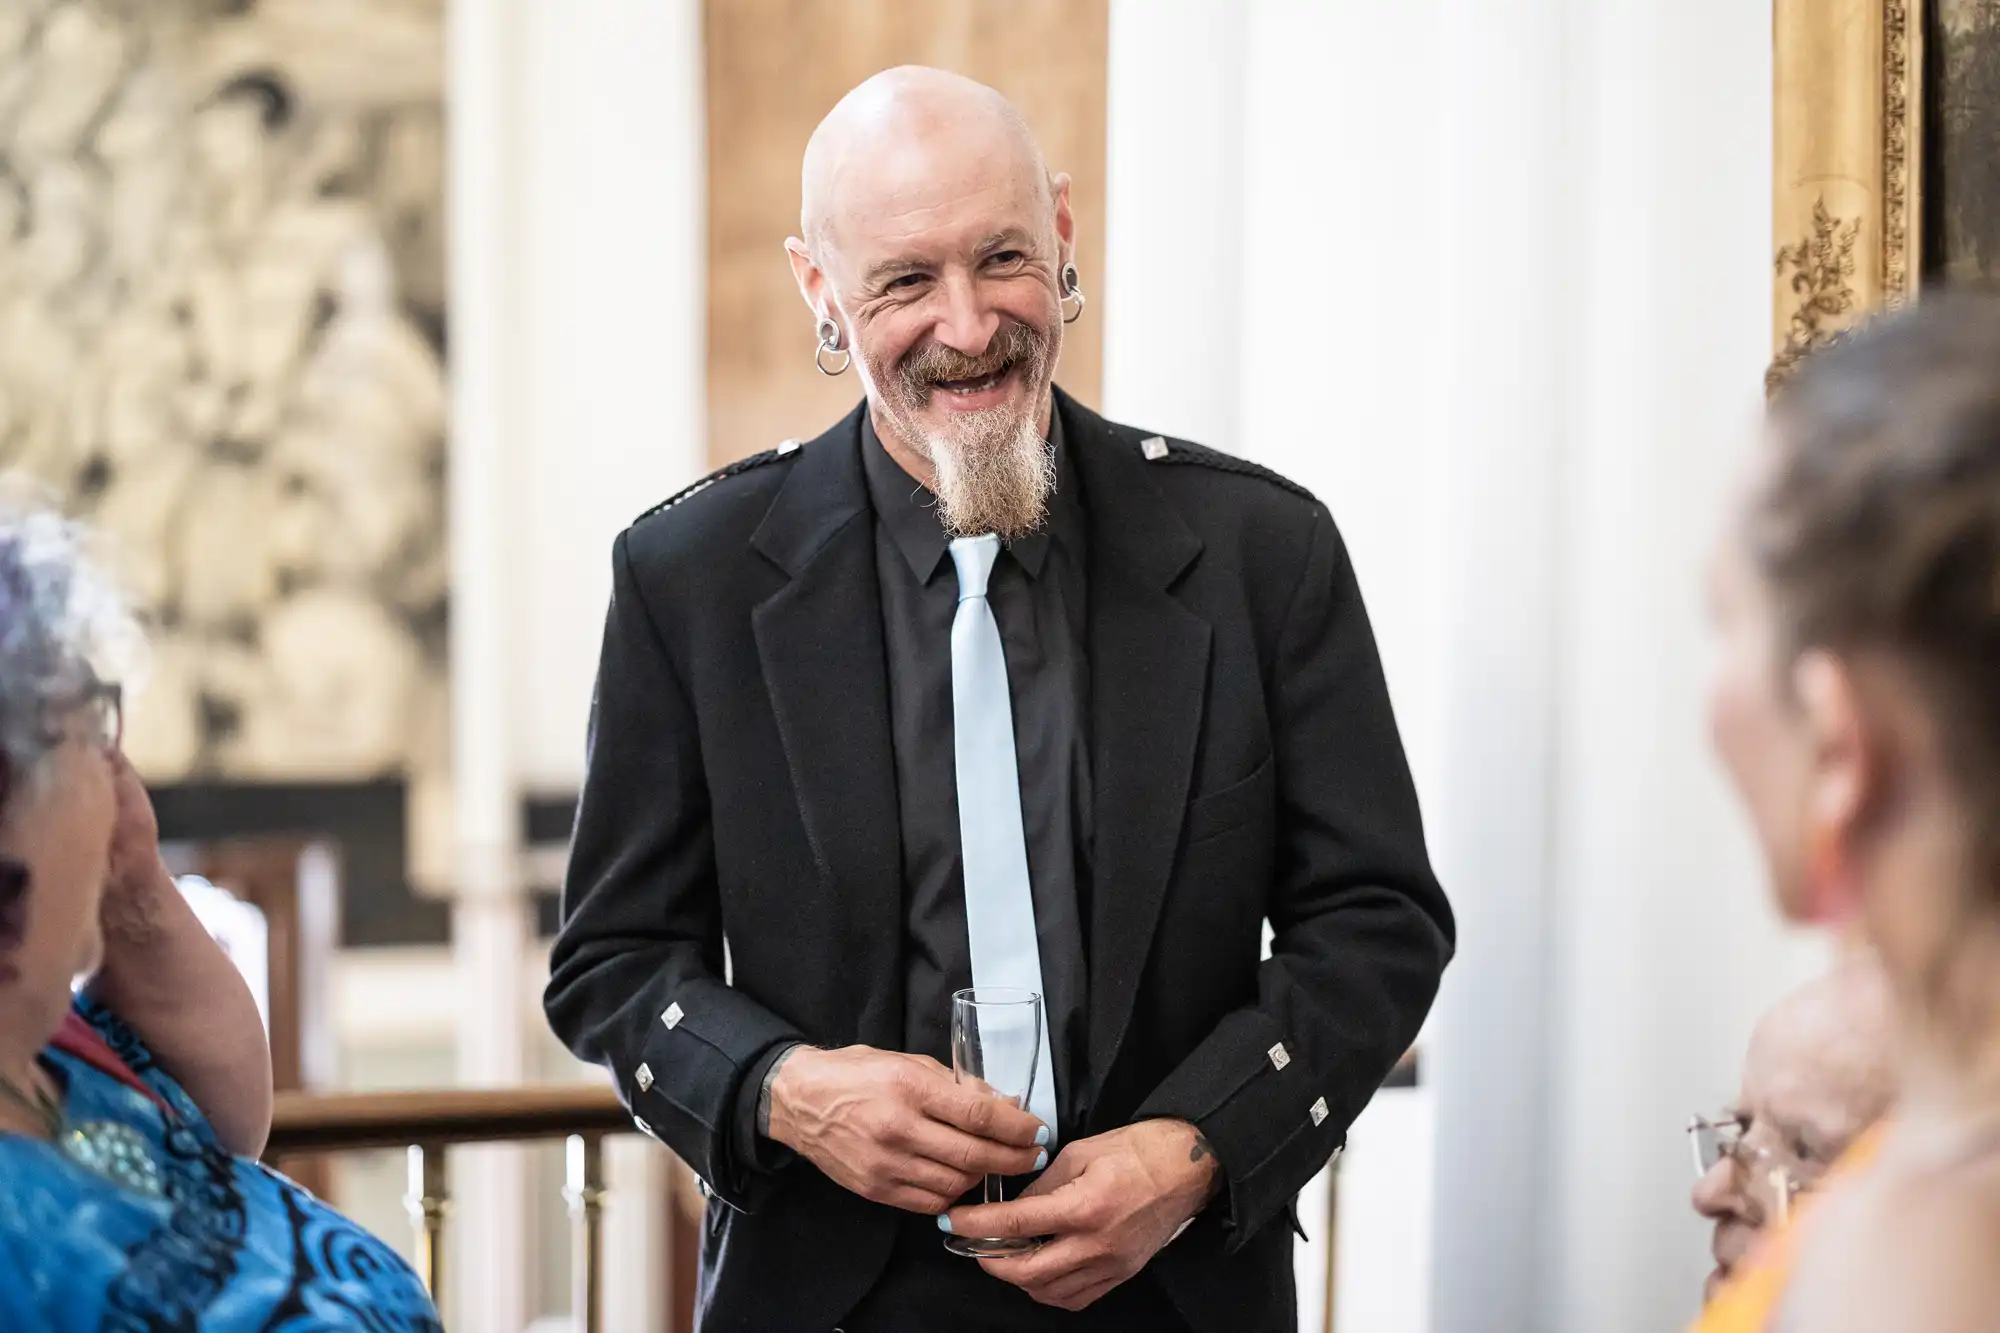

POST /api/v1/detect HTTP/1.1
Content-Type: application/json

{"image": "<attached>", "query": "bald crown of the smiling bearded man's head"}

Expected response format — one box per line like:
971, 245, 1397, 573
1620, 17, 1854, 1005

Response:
800, 64, 1050, 262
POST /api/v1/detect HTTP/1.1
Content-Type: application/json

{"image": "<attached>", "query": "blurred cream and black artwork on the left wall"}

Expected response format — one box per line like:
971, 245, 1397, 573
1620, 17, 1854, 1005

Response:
0, 0, 448, 783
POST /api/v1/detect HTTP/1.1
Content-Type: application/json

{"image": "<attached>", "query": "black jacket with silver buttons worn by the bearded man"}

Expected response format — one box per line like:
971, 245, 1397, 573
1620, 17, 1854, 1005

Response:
546, 392, 1452, 1333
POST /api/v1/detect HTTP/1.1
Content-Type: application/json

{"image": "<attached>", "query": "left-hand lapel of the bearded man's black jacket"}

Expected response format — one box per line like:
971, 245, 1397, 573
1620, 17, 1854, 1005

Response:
752, 408, 904, 1049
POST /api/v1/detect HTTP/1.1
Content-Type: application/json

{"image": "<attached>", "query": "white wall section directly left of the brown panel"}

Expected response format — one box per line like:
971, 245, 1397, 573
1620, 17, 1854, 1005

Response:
512, 0, 712, 791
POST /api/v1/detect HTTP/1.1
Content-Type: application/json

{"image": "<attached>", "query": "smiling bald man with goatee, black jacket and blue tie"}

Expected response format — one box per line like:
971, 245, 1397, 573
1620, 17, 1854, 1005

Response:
548, 68, 1452, 1333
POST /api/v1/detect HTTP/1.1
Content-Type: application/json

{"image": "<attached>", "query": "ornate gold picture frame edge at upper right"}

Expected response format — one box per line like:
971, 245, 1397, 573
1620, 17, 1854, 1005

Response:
1766, 0, 1924, 386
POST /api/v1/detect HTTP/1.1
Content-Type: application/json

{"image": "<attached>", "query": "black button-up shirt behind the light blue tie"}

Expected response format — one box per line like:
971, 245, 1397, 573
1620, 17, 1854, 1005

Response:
862, 414, 1090, 1139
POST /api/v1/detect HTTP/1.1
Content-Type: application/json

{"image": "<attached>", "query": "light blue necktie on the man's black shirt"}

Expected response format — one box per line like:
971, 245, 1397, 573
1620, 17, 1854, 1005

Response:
952, 534, 1056, 1135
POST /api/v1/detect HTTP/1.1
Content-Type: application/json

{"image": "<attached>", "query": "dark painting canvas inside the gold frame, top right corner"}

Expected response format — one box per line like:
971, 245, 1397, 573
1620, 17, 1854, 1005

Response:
1924, 0, 2000, 282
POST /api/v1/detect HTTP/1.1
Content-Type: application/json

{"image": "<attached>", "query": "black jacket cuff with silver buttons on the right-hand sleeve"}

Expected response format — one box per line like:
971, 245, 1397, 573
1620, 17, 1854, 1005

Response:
1134, 1009, 1346, 1253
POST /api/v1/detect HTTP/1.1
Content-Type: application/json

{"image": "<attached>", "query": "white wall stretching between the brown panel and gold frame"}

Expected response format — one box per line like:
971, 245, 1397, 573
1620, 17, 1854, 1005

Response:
1104, 0, 1818, 1333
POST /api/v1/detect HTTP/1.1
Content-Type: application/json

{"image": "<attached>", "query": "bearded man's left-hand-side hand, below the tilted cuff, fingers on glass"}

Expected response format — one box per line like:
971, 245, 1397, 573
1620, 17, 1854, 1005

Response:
770, 1047, 1048, 1215
